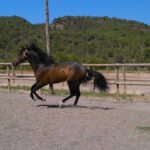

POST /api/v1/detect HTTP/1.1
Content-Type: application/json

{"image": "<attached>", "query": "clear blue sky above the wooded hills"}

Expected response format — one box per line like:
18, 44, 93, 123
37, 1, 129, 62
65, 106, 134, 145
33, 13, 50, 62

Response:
0, 0, 150, 25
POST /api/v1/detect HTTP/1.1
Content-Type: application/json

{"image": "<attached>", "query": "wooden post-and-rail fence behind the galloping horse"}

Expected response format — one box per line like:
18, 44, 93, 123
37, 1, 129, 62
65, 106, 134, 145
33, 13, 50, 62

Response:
0, 63, 150, 100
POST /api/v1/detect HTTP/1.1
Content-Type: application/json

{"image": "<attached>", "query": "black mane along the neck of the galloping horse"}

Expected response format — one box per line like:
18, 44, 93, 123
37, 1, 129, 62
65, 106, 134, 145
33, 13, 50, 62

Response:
29, 44, 54, 65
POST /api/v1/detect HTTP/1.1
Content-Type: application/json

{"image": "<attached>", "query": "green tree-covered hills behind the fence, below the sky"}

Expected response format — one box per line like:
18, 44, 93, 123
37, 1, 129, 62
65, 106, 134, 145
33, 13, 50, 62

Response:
0, 16, 150, 63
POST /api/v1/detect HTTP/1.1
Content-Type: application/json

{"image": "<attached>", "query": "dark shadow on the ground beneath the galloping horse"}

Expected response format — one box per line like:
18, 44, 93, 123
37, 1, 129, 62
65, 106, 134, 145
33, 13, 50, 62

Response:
37, 104, 115, 110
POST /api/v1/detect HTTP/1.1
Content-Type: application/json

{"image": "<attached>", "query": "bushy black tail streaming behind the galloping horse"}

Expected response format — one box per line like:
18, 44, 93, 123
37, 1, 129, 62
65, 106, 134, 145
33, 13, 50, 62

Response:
84, 69, 109, 91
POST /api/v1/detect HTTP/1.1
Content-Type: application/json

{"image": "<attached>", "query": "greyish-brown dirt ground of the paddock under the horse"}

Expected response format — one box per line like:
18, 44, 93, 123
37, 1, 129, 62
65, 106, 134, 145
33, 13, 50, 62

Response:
0, 91, 150, 150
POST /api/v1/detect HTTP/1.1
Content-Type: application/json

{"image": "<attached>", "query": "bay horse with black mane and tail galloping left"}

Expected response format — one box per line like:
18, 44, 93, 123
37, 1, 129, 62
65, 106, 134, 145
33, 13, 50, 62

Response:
12, 44, 109, 107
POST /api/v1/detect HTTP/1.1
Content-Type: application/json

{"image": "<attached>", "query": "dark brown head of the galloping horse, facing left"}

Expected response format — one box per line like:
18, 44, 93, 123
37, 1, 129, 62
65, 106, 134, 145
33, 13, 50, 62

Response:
12, 46, 30, 66
